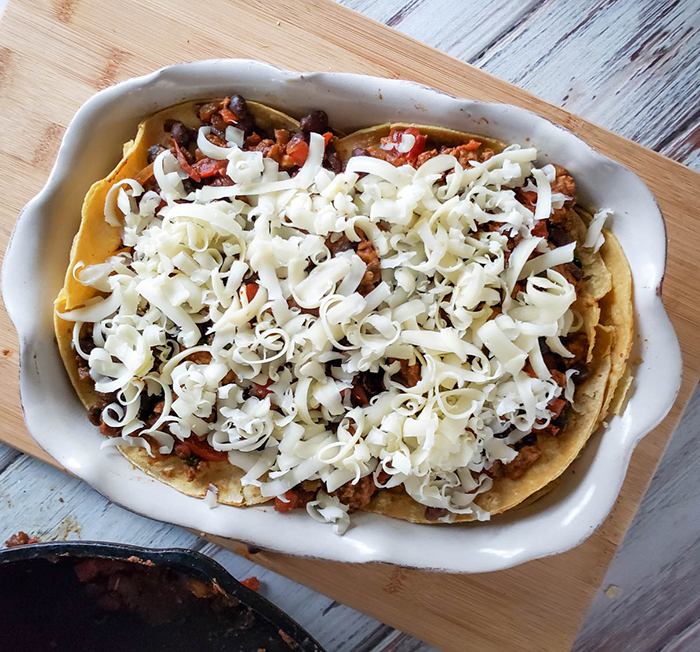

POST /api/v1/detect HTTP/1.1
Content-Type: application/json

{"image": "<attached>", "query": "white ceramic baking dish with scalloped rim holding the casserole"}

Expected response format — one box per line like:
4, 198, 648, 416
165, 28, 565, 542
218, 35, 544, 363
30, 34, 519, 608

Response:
2, 60, 681, 572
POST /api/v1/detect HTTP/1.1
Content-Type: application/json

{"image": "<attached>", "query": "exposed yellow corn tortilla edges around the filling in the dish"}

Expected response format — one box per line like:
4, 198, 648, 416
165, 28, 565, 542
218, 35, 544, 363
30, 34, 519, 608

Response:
55, 112, 633, 523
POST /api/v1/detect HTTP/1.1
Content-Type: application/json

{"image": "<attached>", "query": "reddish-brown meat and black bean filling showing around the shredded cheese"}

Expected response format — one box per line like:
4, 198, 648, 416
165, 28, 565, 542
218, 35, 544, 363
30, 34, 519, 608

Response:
78, 114, 589, 510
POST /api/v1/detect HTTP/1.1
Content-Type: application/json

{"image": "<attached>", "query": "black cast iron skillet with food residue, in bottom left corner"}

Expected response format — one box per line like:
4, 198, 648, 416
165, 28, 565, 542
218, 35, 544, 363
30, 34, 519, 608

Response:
0, 541, 323, 652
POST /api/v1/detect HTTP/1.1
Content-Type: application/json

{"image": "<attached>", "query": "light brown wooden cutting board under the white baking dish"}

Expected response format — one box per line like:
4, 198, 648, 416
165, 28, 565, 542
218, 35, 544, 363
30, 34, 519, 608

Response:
0, 0, 700, 652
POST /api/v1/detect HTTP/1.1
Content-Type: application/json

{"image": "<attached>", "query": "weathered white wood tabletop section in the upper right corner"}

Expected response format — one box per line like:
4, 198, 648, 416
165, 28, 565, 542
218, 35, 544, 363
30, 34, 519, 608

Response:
342, 0, 700, 148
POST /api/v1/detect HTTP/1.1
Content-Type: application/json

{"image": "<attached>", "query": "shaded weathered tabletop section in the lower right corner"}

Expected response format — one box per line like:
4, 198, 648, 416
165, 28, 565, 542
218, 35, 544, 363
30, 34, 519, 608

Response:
574, 389, 700, 652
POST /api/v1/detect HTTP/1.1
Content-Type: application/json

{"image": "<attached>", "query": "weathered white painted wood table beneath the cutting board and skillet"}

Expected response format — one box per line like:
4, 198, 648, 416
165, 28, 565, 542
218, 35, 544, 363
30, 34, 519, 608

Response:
0, 0, 700, 652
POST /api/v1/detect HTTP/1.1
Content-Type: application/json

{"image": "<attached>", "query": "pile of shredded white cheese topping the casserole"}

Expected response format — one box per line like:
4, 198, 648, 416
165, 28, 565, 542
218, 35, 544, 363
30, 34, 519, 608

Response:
60, 127, 584, 523
